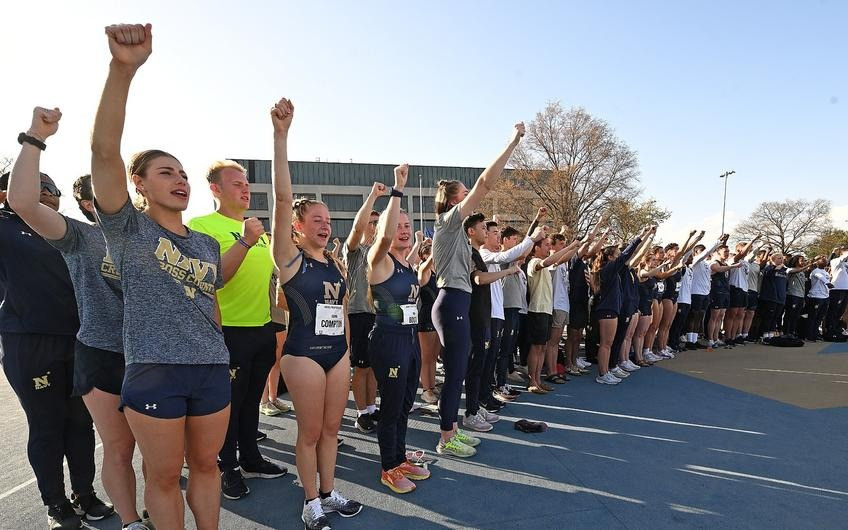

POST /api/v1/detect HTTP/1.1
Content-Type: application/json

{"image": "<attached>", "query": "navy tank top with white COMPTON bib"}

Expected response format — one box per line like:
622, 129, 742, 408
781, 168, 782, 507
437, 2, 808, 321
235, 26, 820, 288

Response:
283, 252, 347, 356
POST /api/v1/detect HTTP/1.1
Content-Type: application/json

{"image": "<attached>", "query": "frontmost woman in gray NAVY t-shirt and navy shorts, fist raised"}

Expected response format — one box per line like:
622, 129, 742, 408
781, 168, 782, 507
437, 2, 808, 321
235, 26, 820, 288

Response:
91, 24, 230, 529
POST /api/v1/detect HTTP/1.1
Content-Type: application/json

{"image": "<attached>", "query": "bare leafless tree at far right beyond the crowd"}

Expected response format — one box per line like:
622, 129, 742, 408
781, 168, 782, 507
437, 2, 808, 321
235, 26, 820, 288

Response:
733, 199, 832, 254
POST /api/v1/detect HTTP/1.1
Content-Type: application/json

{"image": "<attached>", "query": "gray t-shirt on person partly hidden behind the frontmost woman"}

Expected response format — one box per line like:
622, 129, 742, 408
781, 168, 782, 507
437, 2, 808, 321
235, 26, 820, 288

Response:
46, 217, 124, 353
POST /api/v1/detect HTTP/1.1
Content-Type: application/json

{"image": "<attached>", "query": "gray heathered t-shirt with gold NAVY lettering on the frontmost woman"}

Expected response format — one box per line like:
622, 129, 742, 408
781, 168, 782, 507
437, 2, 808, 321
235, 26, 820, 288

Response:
99, 201, 230, 364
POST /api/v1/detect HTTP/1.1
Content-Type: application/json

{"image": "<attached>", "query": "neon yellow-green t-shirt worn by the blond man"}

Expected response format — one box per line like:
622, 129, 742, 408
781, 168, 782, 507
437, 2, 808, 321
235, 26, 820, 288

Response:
188, 212, 274, 327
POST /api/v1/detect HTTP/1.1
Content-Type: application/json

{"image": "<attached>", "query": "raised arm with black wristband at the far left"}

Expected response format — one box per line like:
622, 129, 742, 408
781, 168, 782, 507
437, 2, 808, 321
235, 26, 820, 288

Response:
6, 107, 68, 240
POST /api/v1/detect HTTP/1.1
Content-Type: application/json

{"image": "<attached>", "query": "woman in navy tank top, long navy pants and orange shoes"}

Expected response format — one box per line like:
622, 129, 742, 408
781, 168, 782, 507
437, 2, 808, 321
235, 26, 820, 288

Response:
368, 164, 430, 493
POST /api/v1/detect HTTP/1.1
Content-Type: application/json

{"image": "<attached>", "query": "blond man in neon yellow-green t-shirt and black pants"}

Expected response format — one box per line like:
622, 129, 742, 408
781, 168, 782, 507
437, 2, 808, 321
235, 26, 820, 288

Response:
188, 160, 287, 499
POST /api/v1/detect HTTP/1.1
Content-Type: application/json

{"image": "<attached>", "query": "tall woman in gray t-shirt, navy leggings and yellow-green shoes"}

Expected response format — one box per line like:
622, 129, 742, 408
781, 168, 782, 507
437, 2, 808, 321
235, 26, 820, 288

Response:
433, 123, 524, 456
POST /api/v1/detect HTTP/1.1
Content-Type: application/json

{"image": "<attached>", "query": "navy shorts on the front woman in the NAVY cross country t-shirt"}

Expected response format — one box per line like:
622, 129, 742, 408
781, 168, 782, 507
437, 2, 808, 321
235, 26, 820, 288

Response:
121, 363, 232, 419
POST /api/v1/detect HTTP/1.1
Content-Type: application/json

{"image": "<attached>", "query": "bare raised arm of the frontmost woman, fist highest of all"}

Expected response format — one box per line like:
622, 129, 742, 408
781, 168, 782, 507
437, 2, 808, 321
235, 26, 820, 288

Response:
91, 24, 153, 214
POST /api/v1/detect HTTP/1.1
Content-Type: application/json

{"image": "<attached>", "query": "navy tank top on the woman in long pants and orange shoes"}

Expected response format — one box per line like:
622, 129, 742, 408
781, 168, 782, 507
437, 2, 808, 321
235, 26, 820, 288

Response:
371, 254, 419, 330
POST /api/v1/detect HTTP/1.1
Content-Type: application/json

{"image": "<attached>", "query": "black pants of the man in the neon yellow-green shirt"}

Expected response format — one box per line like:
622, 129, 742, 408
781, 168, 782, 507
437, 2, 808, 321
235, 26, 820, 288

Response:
218, 323, 277, 471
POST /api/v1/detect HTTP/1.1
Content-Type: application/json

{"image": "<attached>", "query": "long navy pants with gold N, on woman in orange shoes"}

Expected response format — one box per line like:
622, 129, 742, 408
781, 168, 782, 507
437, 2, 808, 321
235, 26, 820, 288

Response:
368, 324, 421, 471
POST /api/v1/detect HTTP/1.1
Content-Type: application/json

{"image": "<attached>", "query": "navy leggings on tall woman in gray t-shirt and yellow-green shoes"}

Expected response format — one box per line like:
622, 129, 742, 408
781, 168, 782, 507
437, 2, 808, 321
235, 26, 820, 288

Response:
432, 288, 471, 431
